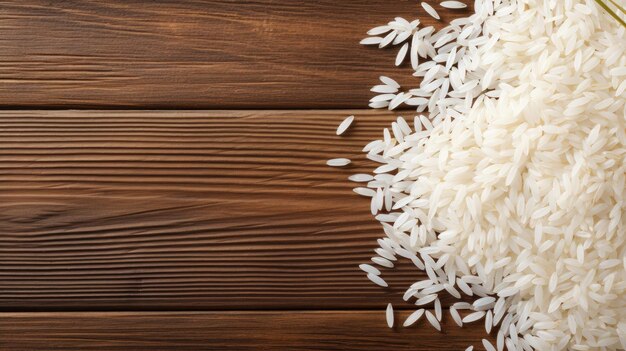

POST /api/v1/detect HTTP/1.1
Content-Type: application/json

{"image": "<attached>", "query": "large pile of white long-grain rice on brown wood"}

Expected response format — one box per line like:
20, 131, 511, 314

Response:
342, 0, 626, 351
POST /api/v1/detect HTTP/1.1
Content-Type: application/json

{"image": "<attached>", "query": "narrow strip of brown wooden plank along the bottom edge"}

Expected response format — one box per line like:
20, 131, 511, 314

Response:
0, 310, 485, 351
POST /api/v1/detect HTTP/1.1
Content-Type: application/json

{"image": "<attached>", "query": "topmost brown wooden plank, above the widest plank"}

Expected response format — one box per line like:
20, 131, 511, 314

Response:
0, 0, 469, 109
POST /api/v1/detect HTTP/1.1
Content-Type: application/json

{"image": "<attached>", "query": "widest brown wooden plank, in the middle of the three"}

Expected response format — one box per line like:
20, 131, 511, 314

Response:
0, 110, 468, 311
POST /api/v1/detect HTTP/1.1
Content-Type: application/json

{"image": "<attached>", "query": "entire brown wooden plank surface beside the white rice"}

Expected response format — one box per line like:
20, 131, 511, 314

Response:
0, 0, 492, 351
